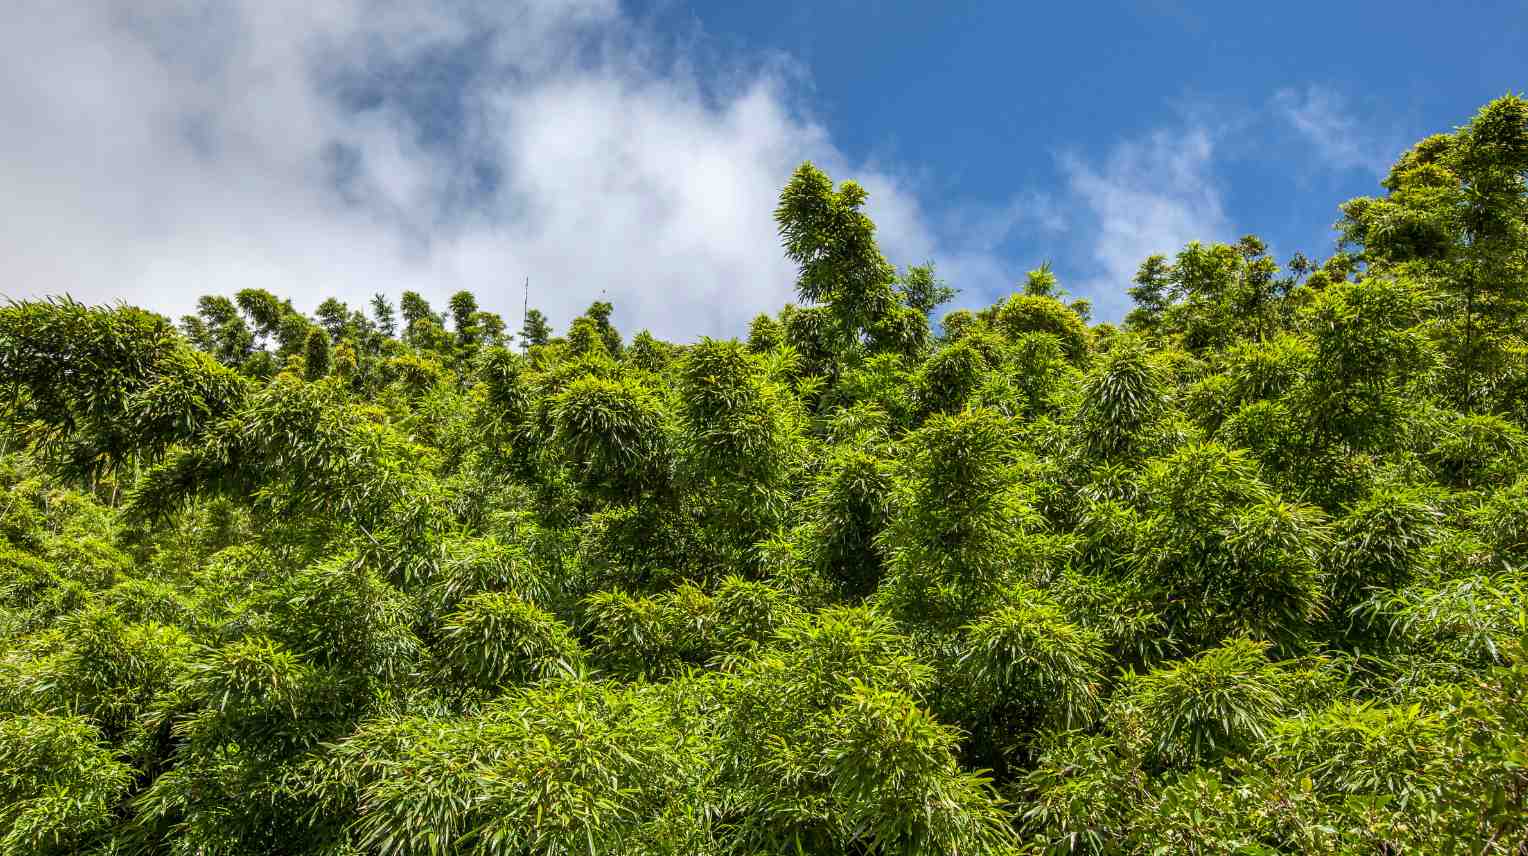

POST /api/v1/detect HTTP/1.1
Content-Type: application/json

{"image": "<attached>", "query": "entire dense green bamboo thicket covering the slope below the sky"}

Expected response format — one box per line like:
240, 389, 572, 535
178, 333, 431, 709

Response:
0, 96, 1528, 854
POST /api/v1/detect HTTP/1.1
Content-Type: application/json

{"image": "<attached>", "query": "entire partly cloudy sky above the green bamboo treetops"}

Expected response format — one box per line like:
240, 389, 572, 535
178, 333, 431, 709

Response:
0, 0, 1528, 339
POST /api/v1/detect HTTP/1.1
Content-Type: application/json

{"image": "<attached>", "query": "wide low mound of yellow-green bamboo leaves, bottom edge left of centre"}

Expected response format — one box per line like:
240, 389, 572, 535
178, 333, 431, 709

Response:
319, 683, 706, 856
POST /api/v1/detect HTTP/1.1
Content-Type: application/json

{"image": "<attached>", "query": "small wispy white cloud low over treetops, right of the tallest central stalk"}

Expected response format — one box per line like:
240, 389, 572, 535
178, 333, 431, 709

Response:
1062, 125, 1233, 318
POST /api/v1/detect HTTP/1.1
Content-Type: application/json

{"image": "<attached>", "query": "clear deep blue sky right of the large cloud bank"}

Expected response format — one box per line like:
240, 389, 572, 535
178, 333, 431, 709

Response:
631, 0, 1528, 313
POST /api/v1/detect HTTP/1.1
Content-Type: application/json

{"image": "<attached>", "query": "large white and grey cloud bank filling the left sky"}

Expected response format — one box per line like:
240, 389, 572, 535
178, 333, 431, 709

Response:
0, 0, 1012, 336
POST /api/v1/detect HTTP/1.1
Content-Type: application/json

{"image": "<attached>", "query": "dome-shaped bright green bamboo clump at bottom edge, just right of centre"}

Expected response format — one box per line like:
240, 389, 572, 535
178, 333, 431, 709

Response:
718, 608, 1008, 853
